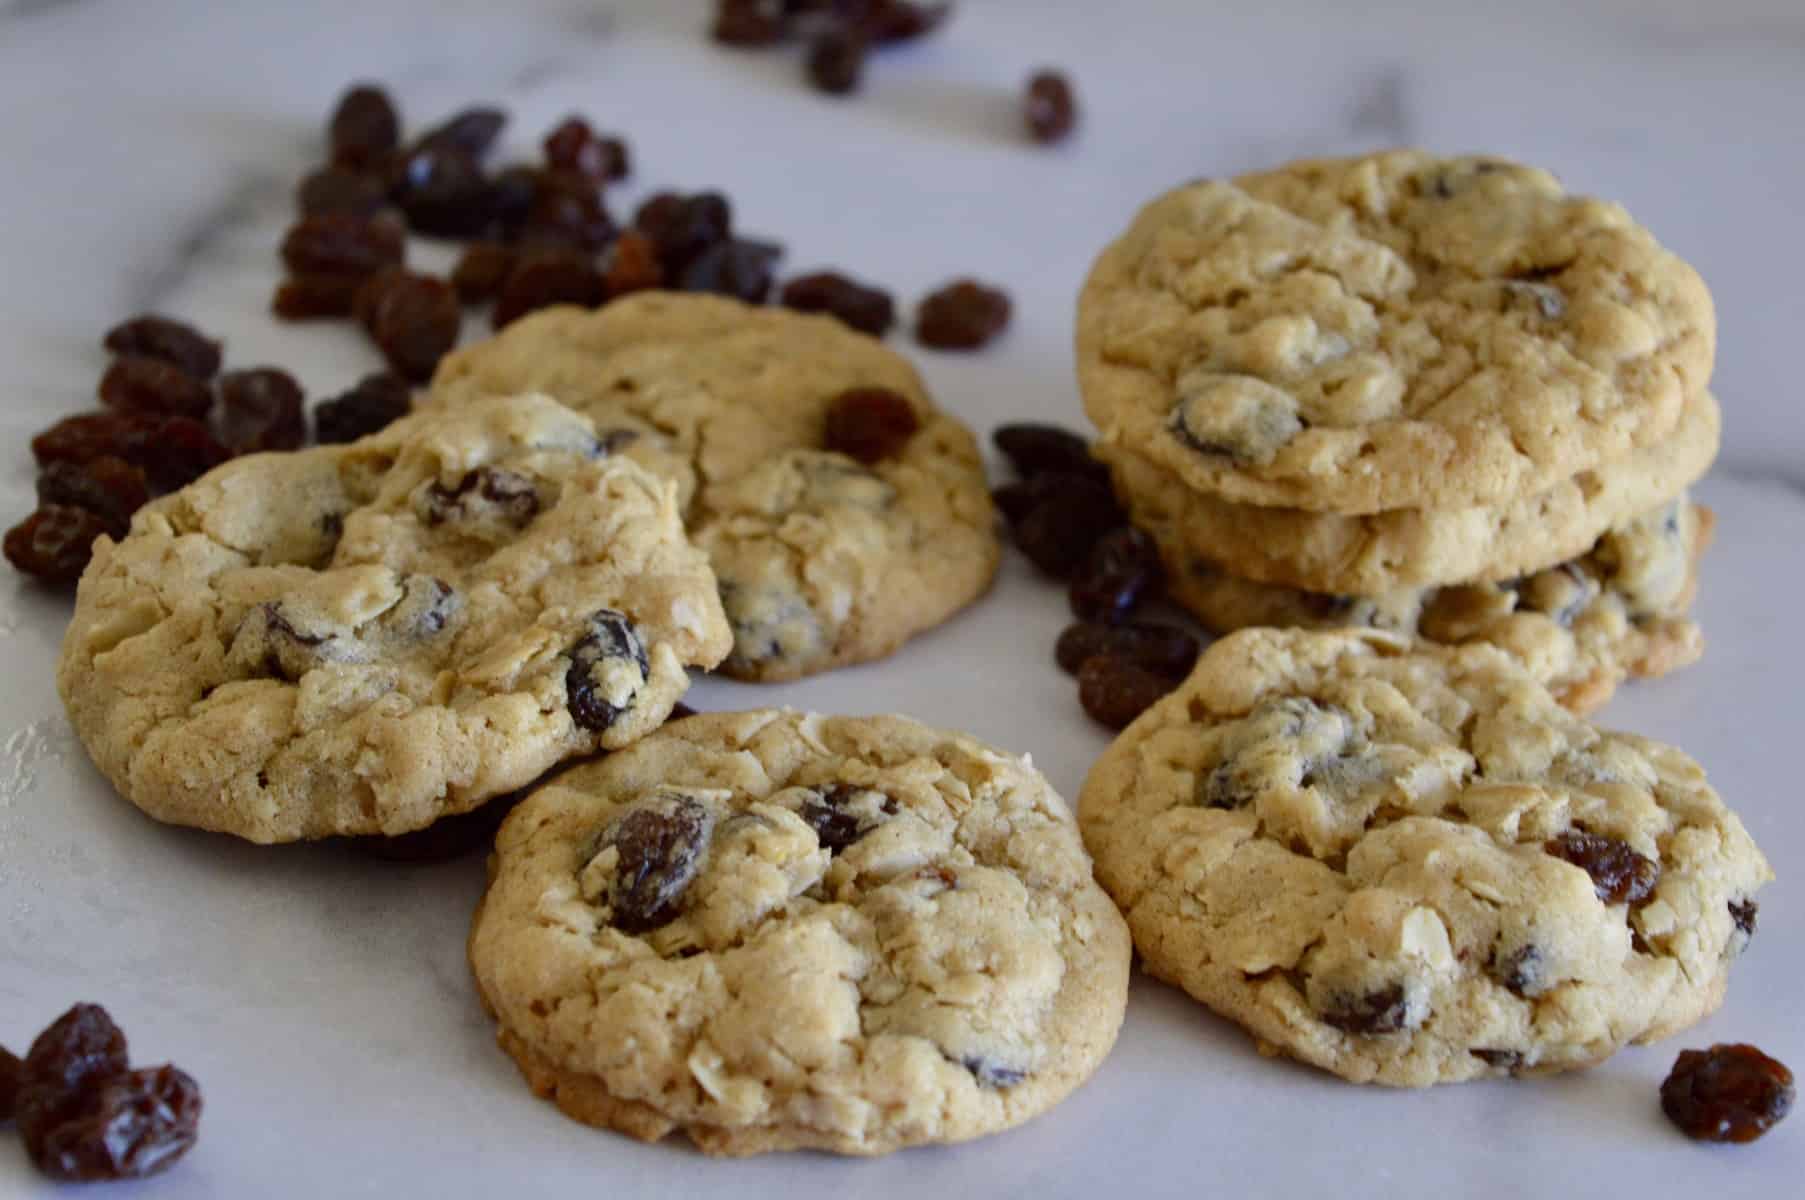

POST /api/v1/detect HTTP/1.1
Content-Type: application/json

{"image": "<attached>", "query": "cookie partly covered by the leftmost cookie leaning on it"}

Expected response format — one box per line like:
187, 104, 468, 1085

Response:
426, 292, 998, 680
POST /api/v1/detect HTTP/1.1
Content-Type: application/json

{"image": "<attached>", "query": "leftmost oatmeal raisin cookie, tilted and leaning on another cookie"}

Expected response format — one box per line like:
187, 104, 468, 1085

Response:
56, 397, 731, 843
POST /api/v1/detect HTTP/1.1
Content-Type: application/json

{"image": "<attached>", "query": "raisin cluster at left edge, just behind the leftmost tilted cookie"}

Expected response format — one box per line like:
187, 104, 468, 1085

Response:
4, 314, 410, 583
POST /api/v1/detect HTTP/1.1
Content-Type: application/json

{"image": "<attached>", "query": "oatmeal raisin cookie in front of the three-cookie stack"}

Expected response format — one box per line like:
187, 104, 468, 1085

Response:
1079, 630, 1773, 1086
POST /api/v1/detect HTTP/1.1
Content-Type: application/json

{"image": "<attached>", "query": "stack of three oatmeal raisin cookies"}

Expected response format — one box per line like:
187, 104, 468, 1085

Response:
1078, 152, 1718, 711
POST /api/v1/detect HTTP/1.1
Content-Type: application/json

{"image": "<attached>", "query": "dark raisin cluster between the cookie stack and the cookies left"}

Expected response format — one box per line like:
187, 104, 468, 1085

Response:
993, 424, 1200, 729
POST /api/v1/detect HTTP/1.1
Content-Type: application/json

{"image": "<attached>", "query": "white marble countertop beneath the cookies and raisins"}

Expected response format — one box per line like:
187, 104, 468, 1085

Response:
0, 0, 1805, 1200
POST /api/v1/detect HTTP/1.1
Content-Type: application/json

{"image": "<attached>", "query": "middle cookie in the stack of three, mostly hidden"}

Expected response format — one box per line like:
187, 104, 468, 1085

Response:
1101, 393, 1720, 595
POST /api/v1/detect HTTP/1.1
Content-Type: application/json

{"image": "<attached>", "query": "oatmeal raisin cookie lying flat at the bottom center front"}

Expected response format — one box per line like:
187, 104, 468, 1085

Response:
469, 709, 1130, 1155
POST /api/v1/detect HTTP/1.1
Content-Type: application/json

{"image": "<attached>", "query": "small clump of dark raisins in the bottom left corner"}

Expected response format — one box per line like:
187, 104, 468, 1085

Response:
0, 1003, 200, 1182
